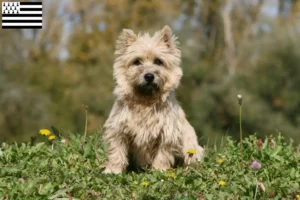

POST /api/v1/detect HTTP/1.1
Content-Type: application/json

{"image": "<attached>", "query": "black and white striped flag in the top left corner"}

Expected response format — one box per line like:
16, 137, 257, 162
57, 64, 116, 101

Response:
2, 2, 43, 29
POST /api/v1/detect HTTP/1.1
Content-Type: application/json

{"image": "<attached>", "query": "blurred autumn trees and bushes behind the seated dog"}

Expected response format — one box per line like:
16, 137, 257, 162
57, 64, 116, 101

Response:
0, 0, 300, 144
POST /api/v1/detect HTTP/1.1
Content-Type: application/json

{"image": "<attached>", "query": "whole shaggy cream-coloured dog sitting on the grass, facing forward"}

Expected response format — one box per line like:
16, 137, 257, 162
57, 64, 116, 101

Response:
104, 26, 203, 173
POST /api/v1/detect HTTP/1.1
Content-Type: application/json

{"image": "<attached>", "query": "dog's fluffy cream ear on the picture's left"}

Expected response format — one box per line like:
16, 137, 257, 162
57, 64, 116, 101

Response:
116, 29, 137, 55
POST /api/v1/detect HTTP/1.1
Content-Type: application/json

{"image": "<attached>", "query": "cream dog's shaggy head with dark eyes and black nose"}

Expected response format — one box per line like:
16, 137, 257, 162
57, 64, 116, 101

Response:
114, 26, 182, 99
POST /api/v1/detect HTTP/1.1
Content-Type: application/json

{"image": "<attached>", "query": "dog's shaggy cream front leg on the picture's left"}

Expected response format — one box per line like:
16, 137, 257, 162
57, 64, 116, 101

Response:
103, 136, 128, 174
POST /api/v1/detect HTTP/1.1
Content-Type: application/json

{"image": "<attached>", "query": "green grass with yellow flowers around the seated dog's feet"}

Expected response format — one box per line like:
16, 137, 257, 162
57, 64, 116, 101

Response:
0, 133, 300, 200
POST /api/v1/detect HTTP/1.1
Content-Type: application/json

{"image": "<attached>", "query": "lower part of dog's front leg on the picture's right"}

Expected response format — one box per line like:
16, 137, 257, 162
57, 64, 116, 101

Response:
152, 149, 175, 170
